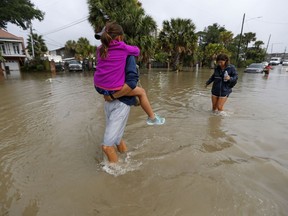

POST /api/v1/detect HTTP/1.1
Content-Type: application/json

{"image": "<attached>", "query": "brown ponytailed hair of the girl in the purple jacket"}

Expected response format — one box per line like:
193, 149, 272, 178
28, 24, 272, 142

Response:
100, 22, 124, 58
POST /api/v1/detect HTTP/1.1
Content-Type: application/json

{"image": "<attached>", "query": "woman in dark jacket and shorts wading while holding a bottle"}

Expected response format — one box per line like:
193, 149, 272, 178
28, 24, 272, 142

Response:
206, 54, 238, 112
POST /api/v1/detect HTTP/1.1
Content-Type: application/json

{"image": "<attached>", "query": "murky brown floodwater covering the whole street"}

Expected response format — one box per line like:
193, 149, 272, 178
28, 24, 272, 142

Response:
0, 66, 288, 216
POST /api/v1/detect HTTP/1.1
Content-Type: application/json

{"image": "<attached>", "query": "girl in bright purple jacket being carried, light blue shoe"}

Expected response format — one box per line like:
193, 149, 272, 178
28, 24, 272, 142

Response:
94, 22, 165, 125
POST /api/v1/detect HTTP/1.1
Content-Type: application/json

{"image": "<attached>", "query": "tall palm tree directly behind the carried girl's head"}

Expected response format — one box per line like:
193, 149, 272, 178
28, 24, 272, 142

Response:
88, 0, 157, 66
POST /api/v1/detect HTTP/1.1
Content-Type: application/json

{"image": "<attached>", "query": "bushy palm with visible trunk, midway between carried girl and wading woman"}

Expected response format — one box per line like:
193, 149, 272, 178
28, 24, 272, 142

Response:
159, 18, 197, 70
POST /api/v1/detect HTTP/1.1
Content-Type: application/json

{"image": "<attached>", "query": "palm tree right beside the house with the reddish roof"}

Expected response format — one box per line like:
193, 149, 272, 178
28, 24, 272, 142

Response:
27, 34, 48, 58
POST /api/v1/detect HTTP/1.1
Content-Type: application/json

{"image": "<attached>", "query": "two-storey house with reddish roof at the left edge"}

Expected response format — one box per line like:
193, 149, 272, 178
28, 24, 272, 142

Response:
0, 29, 26, 73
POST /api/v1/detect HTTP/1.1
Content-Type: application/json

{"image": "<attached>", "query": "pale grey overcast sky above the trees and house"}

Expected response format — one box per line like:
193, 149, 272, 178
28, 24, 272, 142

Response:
7, 0, 288, 53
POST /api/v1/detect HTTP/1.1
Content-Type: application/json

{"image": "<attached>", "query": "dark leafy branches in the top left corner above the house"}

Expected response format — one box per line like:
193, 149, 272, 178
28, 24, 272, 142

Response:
0, 0, 44, 29
